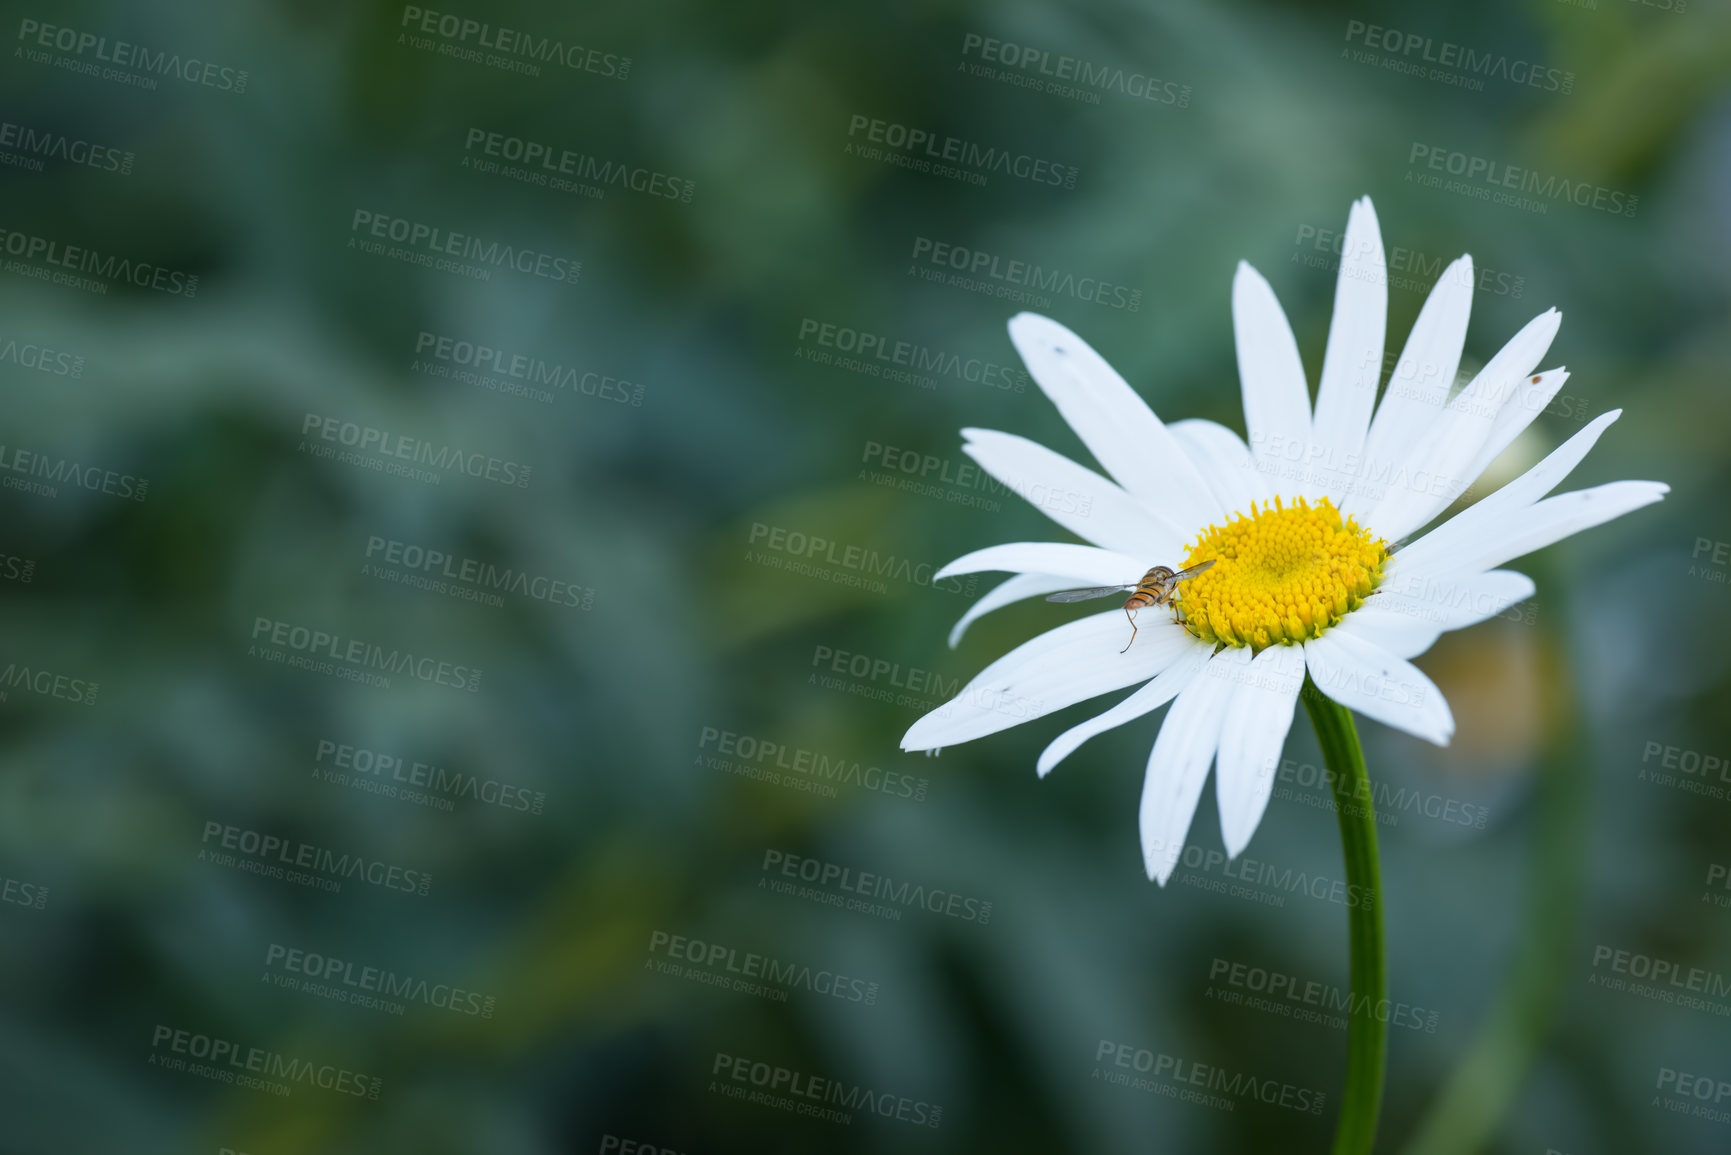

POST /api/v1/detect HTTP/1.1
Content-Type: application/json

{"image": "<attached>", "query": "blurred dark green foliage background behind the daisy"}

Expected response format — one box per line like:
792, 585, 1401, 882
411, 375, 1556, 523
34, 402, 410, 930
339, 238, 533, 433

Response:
0, 0, 1731, 1155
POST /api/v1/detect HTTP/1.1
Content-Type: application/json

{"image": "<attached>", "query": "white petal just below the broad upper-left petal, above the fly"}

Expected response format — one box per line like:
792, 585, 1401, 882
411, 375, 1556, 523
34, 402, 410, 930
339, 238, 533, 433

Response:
962, 429, 1189, 556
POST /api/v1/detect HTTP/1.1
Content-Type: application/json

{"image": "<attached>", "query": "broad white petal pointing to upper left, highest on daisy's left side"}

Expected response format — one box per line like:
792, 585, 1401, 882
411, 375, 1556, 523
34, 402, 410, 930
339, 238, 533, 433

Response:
1009, 313, 1222, 526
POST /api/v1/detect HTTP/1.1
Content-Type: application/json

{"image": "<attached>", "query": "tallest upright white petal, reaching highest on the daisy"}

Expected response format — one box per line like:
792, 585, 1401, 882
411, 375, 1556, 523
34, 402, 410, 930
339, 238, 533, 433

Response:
1310, 197, 1388, 502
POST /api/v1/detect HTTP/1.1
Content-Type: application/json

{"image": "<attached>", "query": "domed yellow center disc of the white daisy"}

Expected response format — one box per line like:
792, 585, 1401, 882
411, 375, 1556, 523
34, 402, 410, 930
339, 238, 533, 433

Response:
1172, 497, 1388, 651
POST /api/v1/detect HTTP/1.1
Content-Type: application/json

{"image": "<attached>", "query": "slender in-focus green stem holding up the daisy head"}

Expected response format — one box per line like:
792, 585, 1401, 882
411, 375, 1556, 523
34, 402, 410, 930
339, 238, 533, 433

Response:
1300, 674, 1388, 1155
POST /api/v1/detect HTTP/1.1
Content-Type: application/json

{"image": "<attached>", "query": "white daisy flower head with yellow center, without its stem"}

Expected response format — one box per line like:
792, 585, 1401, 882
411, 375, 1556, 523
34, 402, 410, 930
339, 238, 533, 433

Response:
902, 197, 1669, 885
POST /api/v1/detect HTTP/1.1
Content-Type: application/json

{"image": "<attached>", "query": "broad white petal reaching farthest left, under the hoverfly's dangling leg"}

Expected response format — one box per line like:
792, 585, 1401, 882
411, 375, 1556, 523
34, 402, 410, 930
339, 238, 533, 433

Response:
902, 610, 1193, 750
